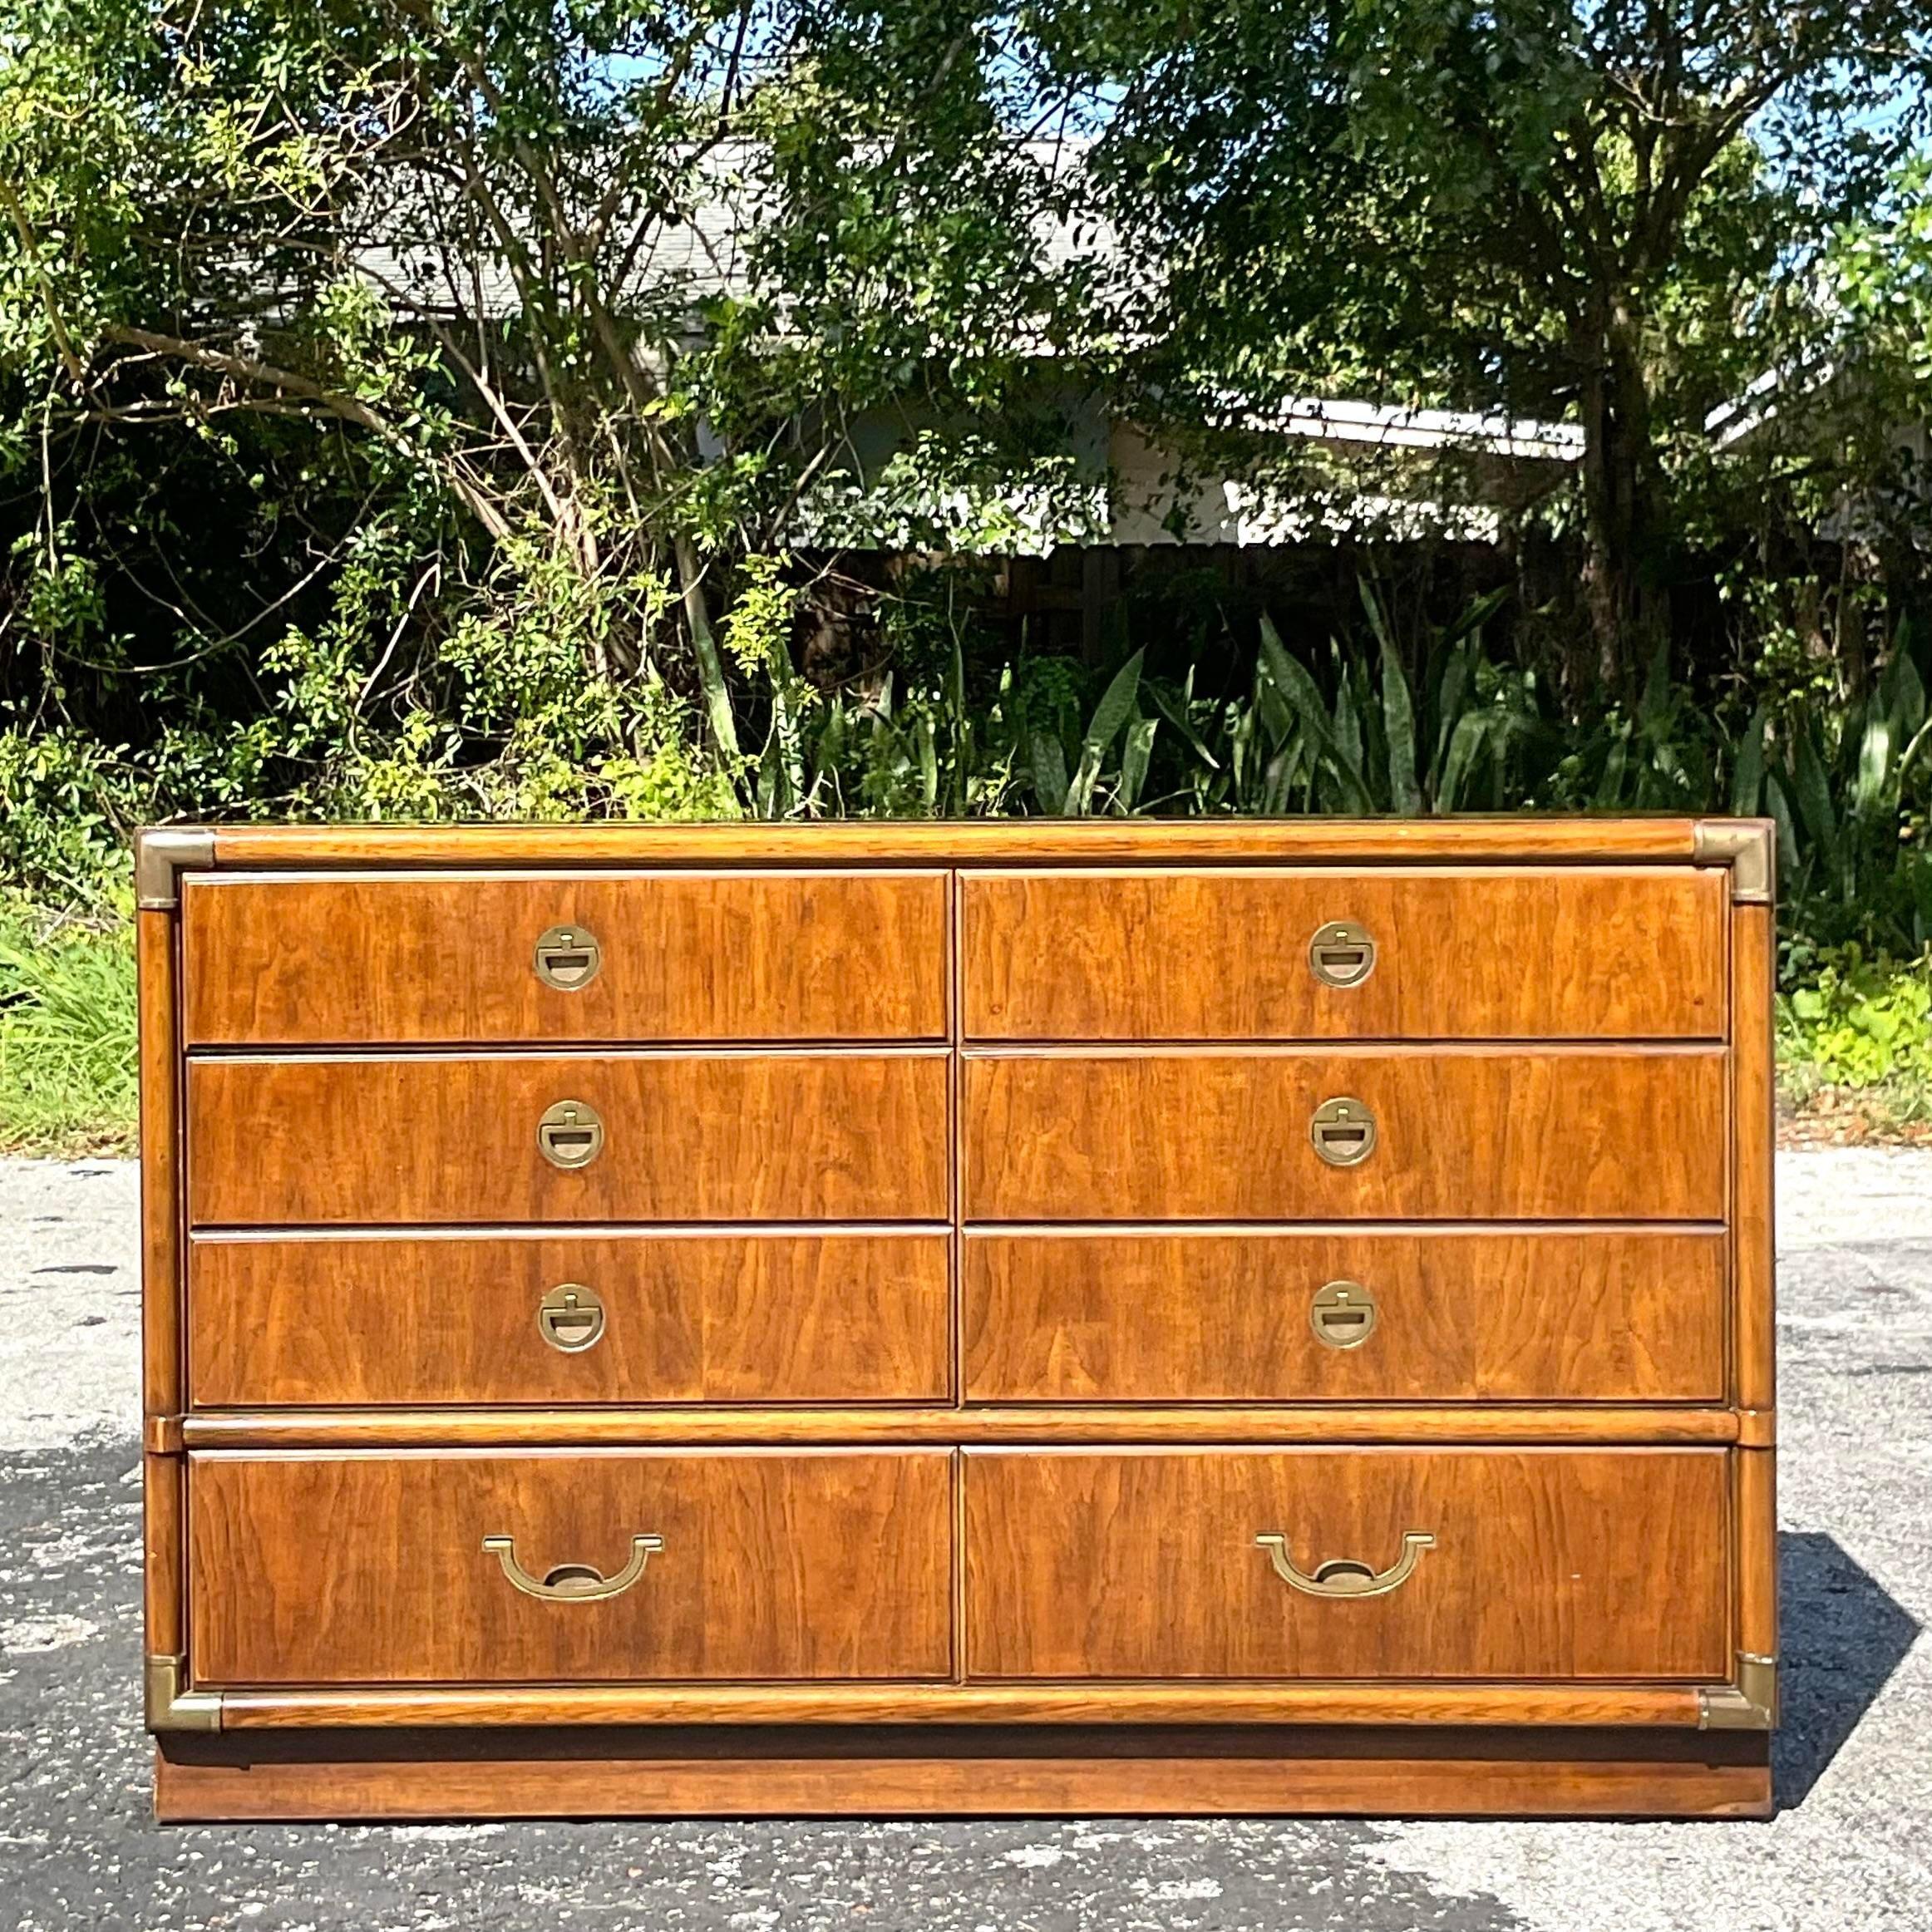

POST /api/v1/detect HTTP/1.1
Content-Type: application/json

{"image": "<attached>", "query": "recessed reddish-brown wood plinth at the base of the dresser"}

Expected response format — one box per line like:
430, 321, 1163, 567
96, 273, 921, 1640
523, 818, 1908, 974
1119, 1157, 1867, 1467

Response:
155, 1725, 1772, 1824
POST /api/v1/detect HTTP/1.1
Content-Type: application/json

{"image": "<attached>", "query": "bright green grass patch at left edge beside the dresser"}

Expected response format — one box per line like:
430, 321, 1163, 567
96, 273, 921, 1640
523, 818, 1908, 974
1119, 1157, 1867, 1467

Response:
0, 899, 137, 1156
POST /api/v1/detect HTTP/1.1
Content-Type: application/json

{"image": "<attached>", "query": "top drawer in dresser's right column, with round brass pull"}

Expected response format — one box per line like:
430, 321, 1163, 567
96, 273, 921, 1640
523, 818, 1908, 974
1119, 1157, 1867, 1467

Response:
960, 865, 1729, 1039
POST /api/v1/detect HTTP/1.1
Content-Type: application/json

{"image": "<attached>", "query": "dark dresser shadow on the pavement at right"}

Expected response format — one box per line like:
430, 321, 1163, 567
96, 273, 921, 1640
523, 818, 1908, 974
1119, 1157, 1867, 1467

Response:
1772, 1530, 1919, 1811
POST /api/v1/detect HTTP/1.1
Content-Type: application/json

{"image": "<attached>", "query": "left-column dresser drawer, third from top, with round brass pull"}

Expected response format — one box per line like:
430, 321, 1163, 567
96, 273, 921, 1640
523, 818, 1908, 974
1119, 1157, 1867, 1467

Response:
187, 1229, 953, 1408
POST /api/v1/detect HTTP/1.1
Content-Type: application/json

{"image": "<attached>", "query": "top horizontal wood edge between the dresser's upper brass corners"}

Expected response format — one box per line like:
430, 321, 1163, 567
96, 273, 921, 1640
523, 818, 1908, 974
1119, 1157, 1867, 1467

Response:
204, 816, 1696, 865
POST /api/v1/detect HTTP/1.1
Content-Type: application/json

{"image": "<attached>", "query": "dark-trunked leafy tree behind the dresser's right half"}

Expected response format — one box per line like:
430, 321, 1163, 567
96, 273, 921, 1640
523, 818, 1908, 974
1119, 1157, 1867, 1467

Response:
1039, 0, 1932, 682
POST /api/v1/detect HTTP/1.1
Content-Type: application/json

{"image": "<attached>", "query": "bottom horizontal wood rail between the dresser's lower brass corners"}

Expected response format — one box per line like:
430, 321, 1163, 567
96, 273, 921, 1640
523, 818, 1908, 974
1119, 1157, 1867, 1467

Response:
200, 1683, 1698, 1731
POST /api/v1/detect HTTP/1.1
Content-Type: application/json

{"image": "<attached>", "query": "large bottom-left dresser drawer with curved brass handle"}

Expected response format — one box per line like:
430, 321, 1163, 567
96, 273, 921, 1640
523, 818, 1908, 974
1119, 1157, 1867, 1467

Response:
187, 1451, 953, 1685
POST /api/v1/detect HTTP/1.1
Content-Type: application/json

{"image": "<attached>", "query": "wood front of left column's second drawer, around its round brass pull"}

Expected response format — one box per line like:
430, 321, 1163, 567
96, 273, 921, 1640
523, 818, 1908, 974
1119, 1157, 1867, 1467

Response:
187, 1049, 947, 1225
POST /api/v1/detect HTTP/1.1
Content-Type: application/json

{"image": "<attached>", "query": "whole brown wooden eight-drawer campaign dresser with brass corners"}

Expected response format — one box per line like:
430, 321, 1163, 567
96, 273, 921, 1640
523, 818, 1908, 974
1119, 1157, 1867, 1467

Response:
137, 817, 1777, 1820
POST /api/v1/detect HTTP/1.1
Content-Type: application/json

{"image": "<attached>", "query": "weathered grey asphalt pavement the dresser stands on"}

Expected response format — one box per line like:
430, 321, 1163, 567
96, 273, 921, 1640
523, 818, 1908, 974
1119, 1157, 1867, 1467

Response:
0, 1150, 1932, 1932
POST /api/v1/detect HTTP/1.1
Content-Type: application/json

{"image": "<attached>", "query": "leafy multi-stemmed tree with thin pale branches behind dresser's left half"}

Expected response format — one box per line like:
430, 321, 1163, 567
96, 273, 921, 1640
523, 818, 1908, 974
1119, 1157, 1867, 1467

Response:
0, 0, 1089, 811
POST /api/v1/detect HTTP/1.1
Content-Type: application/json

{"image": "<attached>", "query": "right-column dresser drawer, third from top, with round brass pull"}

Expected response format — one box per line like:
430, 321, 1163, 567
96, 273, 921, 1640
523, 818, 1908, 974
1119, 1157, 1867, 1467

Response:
962, 1227, 1725, 1402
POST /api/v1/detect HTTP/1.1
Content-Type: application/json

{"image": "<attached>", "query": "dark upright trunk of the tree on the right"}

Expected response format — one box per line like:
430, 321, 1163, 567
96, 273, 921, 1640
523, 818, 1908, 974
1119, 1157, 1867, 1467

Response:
1569, 296, 1668, 697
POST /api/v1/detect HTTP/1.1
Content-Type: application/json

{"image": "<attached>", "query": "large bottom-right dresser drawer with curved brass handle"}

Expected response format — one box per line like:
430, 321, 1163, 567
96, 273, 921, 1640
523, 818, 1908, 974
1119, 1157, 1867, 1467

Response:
966, 1449, 1731, 1681
